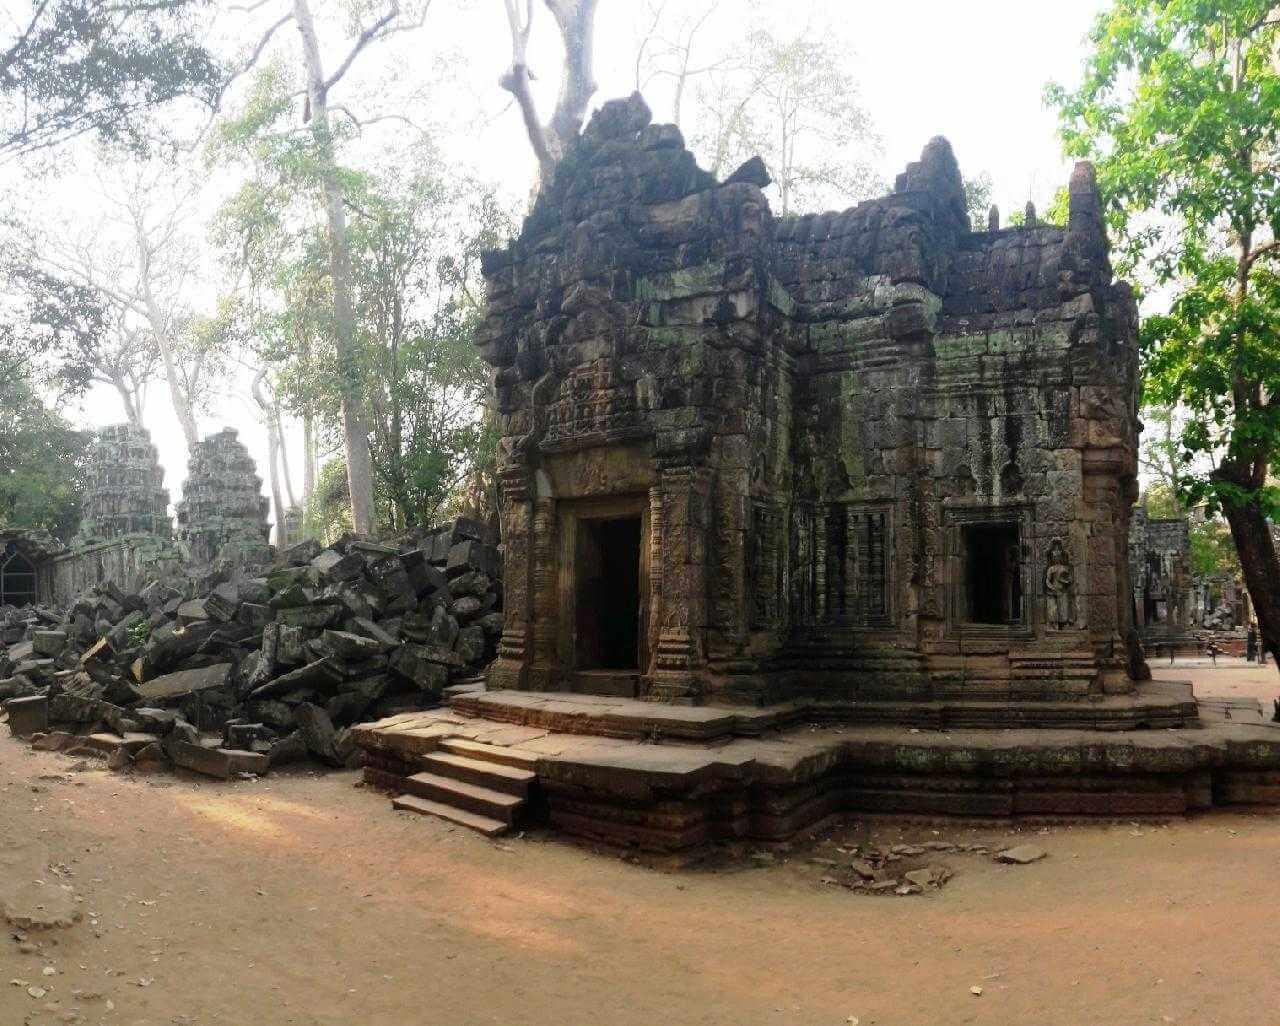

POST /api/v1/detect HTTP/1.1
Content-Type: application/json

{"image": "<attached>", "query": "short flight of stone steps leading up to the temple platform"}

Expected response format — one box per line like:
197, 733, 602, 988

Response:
392, 738, 538, 837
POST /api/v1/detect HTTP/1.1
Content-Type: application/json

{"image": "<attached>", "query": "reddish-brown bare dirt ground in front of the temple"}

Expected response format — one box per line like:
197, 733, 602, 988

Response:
0, 660, 1280, 1026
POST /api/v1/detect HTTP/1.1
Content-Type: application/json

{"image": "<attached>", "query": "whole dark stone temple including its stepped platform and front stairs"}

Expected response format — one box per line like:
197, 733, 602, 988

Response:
355, 96, 1280, 852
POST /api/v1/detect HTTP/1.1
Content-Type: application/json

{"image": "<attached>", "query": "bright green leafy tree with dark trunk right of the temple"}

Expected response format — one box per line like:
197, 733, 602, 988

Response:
1048, 0, 1280, 652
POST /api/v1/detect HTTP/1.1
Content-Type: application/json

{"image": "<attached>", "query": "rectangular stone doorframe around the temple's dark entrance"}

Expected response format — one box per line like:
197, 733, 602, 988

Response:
556, 494, 653, 678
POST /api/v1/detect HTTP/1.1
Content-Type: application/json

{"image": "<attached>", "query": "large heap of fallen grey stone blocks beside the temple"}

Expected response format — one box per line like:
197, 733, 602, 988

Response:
0, 519, 502, 778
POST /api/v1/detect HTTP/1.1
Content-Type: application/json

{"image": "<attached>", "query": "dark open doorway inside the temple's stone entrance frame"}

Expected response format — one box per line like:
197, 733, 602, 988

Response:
575, 517, 640, 670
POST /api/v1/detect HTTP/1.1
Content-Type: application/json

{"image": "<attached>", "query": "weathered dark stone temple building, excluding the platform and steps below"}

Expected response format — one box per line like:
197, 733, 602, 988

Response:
481, 97, 1138, 721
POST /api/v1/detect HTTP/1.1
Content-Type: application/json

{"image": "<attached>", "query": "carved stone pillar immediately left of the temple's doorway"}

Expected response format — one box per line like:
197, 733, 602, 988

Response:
489, 468, 534, 691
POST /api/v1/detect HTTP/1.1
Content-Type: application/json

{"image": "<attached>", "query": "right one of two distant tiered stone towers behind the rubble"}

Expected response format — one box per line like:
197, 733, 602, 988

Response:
177, 427, 271, 565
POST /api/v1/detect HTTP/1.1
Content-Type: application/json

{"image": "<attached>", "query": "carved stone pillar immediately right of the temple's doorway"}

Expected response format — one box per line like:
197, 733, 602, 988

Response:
648, 466, 710, 704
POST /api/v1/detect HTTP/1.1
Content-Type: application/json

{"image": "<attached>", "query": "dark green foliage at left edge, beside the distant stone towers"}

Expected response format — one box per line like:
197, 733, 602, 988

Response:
0, 375, 88, 539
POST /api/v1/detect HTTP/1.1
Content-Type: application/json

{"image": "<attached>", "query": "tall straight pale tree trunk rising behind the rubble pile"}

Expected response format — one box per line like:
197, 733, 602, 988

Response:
293, 0, 374, 535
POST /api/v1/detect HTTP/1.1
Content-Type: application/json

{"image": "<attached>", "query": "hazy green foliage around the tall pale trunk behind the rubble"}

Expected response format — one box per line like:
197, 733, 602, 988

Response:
210, 67, 511, 531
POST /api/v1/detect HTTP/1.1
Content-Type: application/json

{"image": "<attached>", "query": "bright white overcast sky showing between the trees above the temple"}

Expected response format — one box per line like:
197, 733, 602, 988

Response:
62, 0, 1103, 527
